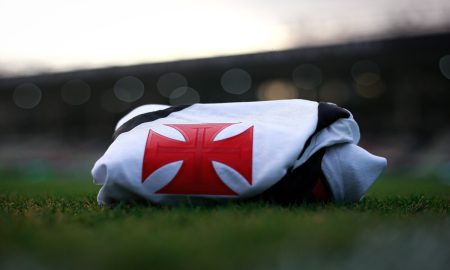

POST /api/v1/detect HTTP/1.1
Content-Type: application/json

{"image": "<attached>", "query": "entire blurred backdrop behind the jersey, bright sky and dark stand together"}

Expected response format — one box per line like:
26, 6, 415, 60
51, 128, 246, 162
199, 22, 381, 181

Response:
0, 0, 450, 183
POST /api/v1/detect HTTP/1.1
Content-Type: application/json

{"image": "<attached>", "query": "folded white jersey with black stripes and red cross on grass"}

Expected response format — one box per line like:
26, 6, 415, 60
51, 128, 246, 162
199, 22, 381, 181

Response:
92, 99, 386, 204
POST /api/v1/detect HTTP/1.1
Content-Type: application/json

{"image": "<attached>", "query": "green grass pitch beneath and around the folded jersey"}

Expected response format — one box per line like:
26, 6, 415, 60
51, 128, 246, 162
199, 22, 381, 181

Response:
0, 173, 450, 269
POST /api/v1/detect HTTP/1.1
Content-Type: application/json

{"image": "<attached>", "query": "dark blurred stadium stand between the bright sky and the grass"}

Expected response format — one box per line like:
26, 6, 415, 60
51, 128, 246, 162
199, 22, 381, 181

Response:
0, 32, 450, 175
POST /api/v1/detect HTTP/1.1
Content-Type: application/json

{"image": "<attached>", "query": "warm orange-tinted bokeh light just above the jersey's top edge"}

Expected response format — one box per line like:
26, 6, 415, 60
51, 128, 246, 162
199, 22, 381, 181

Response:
257, 80, 298, 100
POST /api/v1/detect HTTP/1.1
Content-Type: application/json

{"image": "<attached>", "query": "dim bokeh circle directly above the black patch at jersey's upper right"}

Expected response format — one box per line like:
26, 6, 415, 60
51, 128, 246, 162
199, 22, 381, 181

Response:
319, 80, 351, 105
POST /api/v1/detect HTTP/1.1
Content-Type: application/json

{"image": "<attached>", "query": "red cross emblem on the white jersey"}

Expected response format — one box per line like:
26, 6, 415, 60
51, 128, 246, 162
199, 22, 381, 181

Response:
142, 123, 253, 195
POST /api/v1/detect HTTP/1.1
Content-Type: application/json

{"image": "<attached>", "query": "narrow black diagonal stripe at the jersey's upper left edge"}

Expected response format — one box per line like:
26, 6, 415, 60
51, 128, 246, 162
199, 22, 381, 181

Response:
113, 105, 191, 141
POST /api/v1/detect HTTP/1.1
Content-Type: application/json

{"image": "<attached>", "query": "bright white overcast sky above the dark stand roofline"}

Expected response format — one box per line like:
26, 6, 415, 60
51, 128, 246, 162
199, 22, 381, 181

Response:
0, 0, 450, 76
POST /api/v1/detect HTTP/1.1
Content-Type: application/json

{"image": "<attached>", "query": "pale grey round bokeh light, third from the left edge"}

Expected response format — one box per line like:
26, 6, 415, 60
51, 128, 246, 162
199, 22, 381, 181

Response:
114, 76, 145, 102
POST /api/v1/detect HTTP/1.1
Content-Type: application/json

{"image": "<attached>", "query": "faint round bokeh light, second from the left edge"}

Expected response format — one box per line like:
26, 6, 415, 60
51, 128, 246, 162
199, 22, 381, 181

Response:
61, 80, 91, 105
